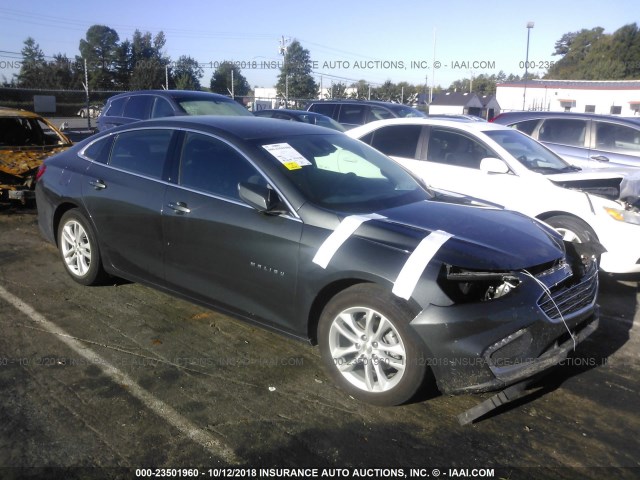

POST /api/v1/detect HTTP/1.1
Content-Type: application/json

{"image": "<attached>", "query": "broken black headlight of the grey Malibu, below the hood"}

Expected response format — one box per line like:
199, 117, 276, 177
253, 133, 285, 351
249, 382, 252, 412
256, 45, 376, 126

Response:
438, 265, 521, 303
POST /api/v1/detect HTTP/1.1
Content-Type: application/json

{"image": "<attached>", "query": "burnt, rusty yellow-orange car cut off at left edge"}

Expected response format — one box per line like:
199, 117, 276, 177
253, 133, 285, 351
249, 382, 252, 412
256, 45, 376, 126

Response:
0, 107, 71, 203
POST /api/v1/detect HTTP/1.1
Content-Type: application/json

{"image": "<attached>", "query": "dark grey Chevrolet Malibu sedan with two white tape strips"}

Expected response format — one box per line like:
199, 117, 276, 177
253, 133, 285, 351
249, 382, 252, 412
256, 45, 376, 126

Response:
36, 117, 598, 405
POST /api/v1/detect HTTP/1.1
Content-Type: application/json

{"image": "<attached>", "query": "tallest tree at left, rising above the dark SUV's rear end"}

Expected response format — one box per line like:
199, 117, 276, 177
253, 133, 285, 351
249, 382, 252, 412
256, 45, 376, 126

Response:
76, 25, 120, 90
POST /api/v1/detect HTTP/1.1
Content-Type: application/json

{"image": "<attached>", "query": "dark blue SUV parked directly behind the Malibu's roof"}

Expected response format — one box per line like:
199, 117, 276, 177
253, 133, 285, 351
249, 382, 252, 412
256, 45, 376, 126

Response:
96, 90, 251, 132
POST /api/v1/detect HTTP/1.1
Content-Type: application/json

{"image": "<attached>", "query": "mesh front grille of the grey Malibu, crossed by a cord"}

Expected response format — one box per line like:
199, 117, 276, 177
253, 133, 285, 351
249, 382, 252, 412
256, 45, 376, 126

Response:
538, 272, 598, 320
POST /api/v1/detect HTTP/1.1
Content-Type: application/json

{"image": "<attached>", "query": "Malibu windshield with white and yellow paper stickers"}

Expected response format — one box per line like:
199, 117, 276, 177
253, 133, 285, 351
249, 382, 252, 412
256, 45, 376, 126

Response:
260, 134, 430, 213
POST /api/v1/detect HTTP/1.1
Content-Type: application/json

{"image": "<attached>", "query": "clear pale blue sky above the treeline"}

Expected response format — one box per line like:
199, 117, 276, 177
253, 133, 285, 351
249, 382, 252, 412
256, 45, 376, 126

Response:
0, 0, 640, 93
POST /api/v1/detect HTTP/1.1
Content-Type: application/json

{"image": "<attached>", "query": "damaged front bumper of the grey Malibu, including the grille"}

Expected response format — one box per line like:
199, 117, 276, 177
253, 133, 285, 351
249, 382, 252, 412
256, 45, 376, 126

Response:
411, 264, 599, 393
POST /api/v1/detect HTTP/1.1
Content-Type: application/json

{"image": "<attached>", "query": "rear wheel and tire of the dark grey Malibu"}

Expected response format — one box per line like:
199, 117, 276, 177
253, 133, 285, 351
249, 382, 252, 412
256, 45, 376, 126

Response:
58, 209, 106, 285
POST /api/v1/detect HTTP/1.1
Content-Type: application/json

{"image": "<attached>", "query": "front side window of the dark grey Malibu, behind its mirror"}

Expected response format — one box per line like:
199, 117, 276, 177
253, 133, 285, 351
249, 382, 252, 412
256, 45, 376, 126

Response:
179, 133, 267, 200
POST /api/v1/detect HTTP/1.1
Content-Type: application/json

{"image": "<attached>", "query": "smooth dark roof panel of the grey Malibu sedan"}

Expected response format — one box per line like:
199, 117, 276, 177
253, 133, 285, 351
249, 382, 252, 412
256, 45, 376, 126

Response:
105, 115, 340, 140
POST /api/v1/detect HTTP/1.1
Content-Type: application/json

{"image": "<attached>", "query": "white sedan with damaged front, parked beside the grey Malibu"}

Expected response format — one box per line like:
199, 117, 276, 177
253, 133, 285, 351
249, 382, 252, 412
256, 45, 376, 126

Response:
347, 118, 640, 273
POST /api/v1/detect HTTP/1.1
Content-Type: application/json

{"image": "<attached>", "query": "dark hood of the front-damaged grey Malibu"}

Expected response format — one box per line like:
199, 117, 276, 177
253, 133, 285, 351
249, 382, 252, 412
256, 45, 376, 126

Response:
358, 200, 564, 271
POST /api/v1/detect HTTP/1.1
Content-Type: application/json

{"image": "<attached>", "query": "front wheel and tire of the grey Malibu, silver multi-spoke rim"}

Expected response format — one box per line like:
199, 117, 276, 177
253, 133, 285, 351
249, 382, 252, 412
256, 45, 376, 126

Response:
318, 284, 426, 406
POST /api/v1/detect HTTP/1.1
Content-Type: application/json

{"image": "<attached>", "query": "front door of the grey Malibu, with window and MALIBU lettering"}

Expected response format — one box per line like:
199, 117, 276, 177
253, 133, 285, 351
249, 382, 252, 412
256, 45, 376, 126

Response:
162, 132, 302, 330
